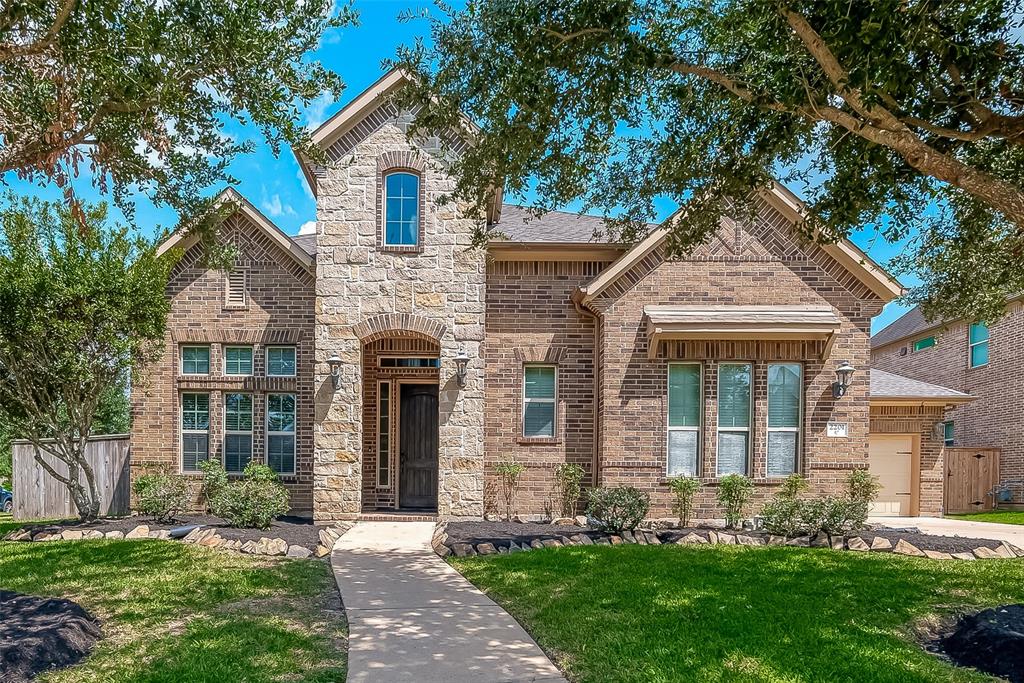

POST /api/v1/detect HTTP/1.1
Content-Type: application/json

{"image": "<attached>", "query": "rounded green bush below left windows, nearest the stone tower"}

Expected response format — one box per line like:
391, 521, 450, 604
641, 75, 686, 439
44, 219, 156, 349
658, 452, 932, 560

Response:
211, 463, 288, 528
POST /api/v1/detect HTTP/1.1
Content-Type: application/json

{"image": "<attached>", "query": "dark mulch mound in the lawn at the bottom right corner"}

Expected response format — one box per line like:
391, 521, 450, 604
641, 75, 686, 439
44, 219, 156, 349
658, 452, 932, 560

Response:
929, 605, 1024, 683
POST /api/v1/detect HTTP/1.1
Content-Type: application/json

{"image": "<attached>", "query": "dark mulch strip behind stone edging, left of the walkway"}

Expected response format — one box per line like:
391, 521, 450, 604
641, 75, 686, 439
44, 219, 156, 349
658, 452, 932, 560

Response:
9, 514, 322, 550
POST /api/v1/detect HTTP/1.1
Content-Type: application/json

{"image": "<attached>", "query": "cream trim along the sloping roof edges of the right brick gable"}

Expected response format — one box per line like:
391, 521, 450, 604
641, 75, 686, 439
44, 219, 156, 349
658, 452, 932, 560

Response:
577, 182, 903, 305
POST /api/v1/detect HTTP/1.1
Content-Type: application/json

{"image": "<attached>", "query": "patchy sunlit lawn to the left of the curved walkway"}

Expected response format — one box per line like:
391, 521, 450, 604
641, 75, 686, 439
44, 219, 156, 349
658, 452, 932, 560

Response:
0, 541, 346, 683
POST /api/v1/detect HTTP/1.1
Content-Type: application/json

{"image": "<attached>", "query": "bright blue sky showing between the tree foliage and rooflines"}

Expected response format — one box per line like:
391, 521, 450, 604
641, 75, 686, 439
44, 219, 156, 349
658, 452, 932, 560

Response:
4, 0, 915, 331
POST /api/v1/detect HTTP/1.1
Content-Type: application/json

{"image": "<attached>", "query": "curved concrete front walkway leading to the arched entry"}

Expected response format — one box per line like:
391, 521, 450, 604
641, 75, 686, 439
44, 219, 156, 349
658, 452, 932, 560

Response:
331, 522, 565, 683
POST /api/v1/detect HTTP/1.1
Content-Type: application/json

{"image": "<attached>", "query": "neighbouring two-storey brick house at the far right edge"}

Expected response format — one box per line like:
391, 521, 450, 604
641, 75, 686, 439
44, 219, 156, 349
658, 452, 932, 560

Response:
871, 297, 1024, 481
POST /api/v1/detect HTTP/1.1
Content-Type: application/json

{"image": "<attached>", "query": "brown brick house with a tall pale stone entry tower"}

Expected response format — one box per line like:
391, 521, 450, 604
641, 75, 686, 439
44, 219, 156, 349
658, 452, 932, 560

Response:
132, 72, 958, 520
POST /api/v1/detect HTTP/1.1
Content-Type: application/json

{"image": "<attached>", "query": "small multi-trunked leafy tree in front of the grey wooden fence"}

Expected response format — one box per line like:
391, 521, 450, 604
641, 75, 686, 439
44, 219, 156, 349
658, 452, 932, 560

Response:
0, 198, 177, 519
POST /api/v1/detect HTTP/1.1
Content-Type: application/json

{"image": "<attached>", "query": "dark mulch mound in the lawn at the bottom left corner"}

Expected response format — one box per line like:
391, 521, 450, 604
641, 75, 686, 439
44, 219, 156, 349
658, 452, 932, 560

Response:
0, 591, 101, 683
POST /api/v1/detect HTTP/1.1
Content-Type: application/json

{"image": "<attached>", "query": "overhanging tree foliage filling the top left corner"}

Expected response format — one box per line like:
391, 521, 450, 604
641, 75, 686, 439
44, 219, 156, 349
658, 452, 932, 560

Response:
0, 0, 354, 250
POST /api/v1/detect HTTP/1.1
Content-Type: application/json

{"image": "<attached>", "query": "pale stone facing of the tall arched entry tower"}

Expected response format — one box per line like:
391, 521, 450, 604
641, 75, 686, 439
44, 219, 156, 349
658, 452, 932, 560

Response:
312, 120, 486, 520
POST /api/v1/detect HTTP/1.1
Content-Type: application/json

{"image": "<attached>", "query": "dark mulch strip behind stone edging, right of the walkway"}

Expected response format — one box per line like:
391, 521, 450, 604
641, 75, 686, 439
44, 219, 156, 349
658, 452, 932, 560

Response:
443, 521, 1000, 553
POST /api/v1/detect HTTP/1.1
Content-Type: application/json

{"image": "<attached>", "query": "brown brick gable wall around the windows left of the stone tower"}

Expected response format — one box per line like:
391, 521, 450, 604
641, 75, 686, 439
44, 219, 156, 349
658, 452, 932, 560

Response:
131, 214, 313, 516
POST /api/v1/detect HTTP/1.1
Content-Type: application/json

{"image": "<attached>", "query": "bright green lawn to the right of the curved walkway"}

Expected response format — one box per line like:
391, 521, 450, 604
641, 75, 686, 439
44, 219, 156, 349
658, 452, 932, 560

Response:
452, 546, 1024, 683
